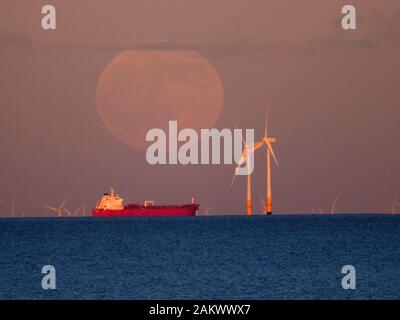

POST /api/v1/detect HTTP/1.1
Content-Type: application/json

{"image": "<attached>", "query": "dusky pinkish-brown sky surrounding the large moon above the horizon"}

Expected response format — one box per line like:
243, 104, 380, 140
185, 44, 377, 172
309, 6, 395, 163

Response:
0, 0, 400, 216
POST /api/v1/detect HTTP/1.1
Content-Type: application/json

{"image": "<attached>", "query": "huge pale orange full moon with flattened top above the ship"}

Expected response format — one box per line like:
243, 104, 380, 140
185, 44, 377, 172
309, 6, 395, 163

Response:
96, 50, 223, 149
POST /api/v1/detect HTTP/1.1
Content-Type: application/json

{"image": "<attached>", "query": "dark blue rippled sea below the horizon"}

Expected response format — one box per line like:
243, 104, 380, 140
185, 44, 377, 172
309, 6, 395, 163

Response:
0, 215, 400, 299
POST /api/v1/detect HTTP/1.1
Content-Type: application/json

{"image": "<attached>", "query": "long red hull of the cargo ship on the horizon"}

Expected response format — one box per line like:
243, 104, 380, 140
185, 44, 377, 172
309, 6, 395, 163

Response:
92, 204, 199, 217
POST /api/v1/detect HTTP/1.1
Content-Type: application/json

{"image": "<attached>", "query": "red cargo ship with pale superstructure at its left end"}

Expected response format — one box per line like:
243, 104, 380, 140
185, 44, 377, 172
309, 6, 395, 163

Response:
92, 188, 199, 217
